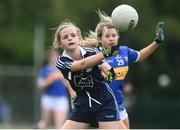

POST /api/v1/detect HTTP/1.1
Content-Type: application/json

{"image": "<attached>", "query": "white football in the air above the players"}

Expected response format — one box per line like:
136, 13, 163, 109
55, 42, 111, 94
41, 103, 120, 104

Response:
111, 4, 138, 32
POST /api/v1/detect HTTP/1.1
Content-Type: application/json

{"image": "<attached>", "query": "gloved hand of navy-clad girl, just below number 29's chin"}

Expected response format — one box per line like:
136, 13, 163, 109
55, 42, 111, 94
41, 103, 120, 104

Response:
101, 45, 119, 58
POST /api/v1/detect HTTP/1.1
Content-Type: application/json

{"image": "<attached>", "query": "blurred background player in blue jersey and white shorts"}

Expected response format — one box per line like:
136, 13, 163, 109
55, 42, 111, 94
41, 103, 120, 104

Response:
37, 50, 69, 129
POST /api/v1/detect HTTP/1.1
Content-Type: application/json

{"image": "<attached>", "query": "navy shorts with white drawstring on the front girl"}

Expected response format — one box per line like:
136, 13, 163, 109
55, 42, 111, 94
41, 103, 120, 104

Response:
69, 86, 119, 123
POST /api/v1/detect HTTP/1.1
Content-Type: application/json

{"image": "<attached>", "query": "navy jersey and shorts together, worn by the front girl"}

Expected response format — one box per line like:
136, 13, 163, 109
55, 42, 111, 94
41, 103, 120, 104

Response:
56, 47, 119, 123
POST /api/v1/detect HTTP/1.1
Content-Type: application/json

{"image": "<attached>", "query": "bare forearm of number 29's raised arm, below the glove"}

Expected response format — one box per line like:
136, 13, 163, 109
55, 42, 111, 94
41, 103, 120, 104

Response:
138, 41, 159, 61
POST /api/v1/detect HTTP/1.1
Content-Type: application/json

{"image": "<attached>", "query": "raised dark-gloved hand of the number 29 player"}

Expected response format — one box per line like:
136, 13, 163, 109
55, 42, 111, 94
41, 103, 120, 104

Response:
154, 21, 164, 44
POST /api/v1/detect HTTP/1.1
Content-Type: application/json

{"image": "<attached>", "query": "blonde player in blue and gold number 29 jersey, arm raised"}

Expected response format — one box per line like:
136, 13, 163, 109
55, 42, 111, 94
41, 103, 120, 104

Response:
83, 11, 164, 128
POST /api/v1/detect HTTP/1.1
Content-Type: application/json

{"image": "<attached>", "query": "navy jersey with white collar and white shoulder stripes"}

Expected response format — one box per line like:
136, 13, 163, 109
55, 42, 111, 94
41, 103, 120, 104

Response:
56, 47, 106, 95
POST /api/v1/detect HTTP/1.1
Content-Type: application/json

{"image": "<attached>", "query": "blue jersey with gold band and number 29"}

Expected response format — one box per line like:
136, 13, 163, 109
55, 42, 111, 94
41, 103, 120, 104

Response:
106, 46, 140, 110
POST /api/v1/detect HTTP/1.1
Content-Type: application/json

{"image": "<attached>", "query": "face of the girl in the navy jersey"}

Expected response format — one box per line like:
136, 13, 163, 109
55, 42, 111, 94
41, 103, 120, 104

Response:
59, 26, 80, 51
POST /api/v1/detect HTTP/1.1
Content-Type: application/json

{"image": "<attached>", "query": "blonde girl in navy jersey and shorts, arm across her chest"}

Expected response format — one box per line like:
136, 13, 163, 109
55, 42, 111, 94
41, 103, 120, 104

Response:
53, 21, 124, 129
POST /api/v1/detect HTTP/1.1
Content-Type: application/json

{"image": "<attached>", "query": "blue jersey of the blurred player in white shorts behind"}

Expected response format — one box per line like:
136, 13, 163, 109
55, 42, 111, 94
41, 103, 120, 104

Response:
38, 65, 68, 96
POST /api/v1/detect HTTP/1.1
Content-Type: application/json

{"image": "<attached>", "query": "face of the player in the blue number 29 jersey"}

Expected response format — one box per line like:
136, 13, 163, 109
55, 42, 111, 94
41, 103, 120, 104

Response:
100, 28, 119, 48
